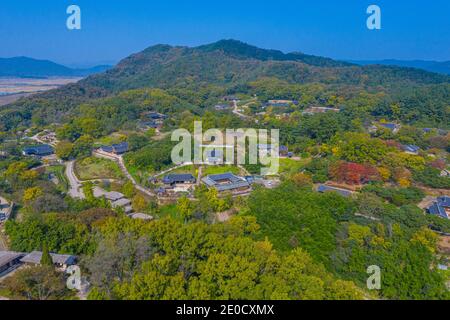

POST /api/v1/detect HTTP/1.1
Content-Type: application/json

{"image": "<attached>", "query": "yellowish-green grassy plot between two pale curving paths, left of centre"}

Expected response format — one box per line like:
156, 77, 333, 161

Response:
75, 157, 124, 181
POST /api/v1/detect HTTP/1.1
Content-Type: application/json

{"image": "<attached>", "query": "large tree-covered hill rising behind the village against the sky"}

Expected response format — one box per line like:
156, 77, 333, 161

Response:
0, 40, 450, 130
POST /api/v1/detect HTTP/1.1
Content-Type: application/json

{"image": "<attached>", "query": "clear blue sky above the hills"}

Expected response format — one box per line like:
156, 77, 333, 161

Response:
0, 0, 450, 65
